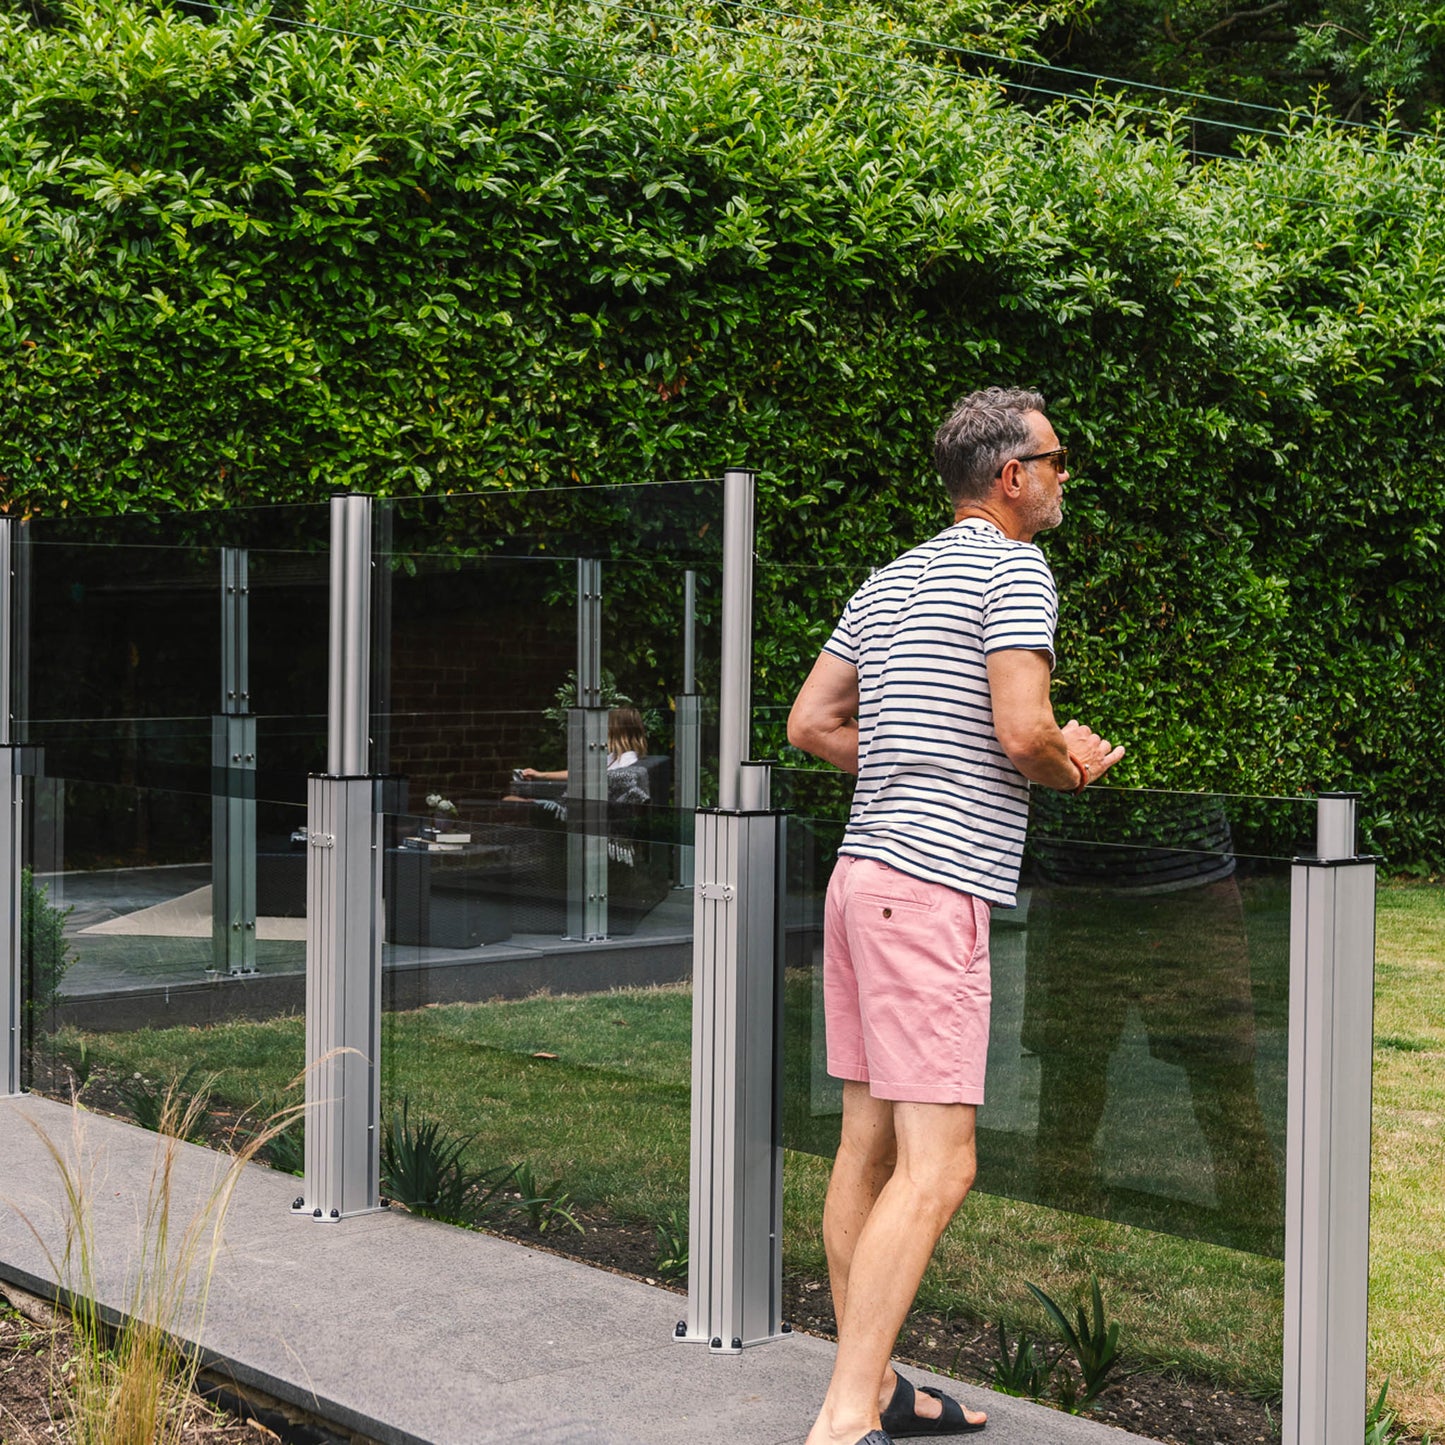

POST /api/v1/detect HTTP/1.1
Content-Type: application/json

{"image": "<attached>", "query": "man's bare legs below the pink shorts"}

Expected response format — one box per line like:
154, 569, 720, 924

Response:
808, 1085, 977, 1445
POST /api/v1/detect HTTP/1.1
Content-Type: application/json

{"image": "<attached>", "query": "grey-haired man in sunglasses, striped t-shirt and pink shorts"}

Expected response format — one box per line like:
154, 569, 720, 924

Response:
788, 387, 1124, 1445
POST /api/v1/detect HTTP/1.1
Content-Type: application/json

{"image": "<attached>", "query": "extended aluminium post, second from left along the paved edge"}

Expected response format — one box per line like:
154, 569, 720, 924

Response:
292, 496, 381, 1222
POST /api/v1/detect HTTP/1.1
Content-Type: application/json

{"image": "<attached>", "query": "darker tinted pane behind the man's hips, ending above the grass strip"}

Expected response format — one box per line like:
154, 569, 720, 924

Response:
776, 770, 1314, 1256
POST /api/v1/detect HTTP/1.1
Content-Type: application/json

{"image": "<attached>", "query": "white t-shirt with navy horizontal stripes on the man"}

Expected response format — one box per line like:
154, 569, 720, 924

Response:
827, 517, 1058, 907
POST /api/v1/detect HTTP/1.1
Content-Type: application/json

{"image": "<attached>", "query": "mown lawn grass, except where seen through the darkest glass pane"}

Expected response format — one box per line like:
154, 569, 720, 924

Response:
42, 887, 1445, 1435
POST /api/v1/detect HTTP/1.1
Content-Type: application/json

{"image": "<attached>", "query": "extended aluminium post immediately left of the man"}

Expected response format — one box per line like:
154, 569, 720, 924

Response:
673, 471, 788, 1354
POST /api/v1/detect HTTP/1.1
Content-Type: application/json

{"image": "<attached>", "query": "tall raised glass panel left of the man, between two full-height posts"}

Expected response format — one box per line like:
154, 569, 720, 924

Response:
373, 483, 721, 1253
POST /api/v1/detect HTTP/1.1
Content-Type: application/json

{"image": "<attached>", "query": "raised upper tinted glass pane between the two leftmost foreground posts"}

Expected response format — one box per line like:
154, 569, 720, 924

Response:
16, 507, 329, 803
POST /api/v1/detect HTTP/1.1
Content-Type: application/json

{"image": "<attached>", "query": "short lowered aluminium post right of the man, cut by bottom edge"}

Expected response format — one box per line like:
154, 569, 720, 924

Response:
1282, 793, 1376, 1445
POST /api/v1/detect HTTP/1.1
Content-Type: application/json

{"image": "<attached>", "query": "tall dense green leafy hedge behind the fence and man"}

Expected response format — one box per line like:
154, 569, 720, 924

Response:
8, 3, 1445, 868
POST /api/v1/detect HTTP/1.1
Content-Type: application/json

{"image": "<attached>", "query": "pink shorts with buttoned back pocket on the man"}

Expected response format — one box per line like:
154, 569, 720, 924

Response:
822, 857, 990, 1104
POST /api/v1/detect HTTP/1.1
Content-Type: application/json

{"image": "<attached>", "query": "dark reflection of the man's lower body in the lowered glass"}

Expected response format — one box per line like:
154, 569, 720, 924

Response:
1022, 795, 1282, 1253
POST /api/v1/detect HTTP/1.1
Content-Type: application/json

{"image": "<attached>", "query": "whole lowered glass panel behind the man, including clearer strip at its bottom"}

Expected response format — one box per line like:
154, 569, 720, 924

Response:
775, 769, 1315, 1386
